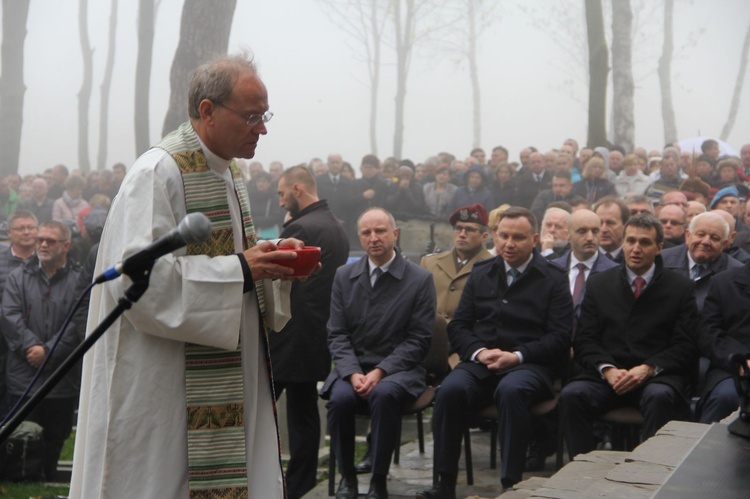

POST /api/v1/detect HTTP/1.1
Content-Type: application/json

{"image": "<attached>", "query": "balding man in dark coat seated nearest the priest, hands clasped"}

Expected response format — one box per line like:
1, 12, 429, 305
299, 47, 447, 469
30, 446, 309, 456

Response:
321, 208, 436, 499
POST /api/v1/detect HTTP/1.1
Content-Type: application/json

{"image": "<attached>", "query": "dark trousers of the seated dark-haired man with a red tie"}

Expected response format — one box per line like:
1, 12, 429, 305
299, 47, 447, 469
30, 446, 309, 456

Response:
560, 380, 686, 460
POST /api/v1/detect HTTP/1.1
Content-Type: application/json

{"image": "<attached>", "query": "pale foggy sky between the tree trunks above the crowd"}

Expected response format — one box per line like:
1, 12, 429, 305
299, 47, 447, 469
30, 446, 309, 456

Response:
10, 0, 750, 173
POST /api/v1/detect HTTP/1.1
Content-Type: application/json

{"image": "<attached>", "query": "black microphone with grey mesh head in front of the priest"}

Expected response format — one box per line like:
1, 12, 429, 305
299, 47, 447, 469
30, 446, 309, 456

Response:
94, 212, 212, 284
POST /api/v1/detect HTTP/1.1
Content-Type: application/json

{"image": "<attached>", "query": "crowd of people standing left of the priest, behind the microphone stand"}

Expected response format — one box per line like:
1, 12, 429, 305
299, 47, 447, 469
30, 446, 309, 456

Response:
0, 164, 125, 480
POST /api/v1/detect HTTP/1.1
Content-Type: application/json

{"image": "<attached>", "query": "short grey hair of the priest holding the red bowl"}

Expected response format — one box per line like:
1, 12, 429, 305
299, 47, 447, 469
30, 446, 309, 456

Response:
188, 51, 258, 119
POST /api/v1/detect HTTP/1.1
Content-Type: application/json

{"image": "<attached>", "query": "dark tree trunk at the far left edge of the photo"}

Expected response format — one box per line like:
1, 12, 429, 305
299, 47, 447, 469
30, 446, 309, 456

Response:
0, 0, 29, 177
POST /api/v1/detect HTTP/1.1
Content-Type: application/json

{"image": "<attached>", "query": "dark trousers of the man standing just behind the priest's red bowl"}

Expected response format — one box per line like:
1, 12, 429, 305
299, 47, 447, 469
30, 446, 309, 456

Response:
274, 381, 320, 499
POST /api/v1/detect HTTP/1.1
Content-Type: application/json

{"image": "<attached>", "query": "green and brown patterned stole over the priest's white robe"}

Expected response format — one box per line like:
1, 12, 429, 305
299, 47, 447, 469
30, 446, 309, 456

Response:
156, 122, 275, 498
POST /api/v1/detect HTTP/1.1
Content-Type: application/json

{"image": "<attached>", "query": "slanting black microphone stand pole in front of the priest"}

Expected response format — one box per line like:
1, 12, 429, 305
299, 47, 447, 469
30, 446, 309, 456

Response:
0, 261, 154, 443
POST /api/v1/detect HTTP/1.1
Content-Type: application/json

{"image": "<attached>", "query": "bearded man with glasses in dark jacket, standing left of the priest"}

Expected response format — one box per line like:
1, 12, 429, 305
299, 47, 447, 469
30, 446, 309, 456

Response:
3, 221, 83, 480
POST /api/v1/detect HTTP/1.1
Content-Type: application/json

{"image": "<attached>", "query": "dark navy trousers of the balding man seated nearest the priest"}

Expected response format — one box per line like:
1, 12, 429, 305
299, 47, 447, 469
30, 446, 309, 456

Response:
326, 378, 414, 476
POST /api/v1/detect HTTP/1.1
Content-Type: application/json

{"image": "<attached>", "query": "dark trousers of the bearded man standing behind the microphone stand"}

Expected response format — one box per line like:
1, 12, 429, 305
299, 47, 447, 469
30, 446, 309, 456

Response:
12, 397, 78, 480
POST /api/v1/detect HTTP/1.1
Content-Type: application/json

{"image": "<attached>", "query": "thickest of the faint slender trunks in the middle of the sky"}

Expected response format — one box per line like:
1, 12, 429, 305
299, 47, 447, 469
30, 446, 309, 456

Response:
393, 0, 416, 159
